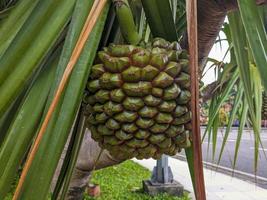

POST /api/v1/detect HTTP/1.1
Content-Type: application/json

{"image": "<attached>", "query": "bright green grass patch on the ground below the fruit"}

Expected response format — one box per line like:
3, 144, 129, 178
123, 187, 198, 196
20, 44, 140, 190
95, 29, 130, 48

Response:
84, 161, 190, 200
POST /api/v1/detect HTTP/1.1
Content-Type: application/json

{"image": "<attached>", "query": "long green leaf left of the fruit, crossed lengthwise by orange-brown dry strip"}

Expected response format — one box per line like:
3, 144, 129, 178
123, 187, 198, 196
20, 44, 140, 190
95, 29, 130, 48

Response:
17, 0, 109, 200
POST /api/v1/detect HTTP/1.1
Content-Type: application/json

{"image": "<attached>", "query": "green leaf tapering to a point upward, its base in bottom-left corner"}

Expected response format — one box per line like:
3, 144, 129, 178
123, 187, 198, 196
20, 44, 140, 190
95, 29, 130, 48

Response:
0, 48, 61, 199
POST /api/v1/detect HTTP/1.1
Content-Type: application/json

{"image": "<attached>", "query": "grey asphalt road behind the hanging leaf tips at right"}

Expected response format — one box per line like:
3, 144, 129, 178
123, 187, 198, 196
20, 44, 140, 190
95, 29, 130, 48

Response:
178, 128, 267, 188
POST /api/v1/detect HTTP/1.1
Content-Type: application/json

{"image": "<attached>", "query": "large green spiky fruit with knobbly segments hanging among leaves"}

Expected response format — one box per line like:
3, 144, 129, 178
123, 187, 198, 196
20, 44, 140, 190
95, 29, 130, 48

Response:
85, 38, 191, 159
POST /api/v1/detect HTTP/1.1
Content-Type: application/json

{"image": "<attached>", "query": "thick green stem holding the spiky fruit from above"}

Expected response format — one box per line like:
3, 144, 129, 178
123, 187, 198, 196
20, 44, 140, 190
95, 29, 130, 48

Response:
113, 0, 141, 45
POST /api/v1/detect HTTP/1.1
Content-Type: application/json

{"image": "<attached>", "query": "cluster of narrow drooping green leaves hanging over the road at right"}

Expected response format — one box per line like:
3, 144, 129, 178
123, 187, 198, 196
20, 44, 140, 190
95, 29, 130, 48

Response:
204, 3, 267, 173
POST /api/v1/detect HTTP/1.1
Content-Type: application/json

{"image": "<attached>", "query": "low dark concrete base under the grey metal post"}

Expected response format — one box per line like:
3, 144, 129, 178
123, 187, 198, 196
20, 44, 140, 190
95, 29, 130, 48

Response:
143, 180, 184, 197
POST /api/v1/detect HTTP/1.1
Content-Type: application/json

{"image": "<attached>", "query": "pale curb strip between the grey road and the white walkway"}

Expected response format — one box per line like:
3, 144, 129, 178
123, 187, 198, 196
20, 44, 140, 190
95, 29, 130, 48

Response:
172, 155, 267, 189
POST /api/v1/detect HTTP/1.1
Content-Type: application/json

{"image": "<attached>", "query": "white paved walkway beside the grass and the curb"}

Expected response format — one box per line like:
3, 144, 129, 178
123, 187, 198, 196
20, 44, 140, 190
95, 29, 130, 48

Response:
133, 158, 267, 200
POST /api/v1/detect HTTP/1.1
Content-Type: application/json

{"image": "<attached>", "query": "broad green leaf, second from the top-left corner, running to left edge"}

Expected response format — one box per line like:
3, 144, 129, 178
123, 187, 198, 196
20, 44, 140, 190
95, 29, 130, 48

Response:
0, 0, 75, 116
